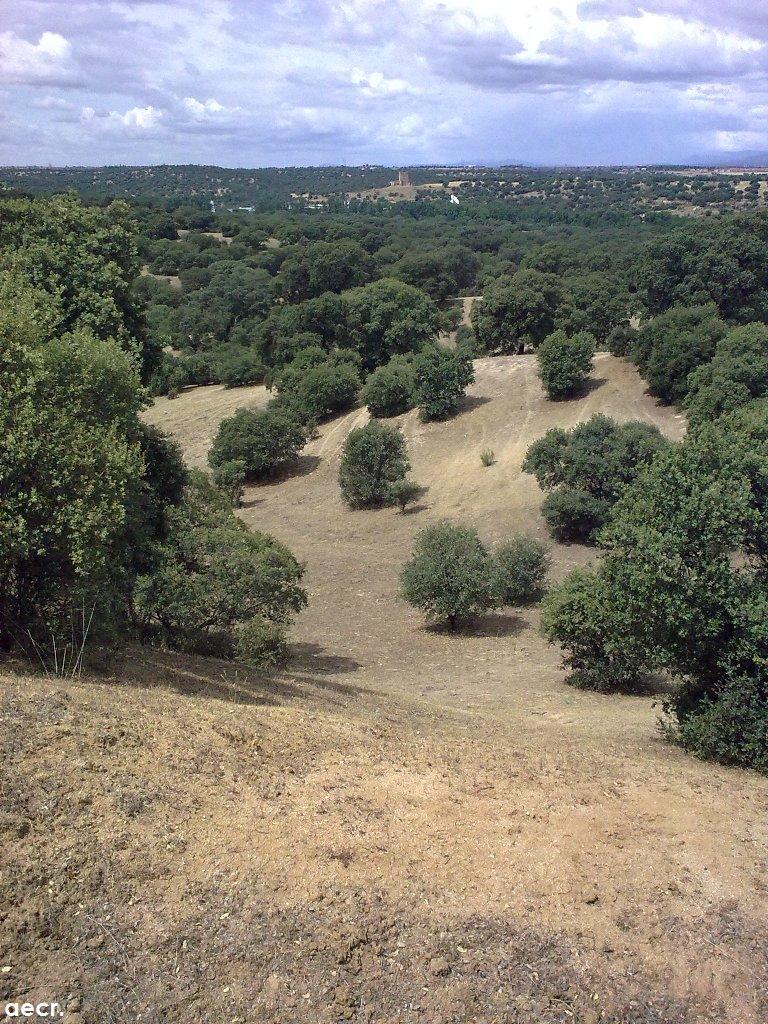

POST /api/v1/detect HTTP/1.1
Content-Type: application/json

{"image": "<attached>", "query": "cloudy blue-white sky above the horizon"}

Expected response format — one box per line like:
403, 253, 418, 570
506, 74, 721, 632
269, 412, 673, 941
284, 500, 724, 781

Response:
0, 0, 768, 167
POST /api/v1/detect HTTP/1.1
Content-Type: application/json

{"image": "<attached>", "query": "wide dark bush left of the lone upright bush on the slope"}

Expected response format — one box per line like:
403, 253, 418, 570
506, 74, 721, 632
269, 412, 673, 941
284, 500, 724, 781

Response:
208, 409, 306, 479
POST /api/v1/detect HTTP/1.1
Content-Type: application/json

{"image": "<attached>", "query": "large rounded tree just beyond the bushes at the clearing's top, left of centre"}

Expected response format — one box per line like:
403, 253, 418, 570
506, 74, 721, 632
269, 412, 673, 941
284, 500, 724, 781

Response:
343, 279, 440, 370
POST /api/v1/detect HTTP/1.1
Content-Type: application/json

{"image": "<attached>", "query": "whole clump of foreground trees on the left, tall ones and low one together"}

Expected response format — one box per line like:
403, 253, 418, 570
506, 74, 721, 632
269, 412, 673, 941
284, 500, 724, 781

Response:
0, 198, 306, 675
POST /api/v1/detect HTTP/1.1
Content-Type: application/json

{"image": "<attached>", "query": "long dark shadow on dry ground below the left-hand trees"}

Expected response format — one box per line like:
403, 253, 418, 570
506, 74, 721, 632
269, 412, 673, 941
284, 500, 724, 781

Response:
105, 644, 370, 705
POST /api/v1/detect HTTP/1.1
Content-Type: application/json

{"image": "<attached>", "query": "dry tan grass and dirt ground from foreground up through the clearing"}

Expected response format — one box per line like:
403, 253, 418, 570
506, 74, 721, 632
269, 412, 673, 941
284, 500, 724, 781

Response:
0, 355, 768, 1024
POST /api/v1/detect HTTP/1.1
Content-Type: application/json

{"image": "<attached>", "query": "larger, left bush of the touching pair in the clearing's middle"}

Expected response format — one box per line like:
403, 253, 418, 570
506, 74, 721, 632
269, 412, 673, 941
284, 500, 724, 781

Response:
400, 521, 499, 629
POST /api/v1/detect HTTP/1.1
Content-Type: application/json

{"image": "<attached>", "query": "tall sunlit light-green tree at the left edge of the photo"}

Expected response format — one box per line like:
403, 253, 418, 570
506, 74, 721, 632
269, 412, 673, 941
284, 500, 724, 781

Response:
0, 273, 143, 650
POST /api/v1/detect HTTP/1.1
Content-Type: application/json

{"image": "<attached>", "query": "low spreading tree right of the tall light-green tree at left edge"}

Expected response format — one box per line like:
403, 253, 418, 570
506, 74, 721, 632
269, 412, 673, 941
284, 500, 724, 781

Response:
133, 478, 307, 660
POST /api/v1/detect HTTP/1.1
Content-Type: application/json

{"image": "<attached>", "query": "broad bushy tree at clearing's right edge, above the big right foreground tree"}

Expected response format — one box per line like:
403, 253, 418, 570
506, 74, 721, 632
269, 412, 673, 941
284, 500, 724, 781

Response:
522, 415, 668, 542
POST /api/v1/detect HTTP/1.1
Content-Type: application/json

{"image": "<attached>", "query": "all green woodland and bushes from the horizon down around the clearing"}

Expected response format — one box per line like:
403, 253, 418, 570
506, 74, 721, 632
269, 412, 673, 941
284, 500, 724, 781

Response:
0, 168, 768, 771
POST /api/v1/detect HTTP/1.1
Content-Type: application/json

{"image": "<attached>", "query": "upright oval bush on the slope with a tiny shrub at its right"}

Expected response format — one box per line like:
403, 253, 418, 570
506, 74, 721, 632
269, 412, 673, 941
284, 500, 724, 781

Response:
339, 420, 411, 509
